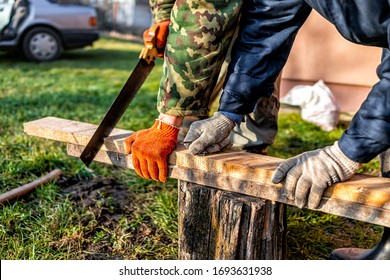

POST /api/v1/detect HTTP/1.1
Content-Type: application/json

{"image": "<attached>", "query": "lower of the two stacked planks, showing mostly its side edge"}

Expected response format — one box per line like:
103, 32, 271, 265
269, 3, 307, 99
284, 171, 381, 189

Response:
67, 144, 390, 227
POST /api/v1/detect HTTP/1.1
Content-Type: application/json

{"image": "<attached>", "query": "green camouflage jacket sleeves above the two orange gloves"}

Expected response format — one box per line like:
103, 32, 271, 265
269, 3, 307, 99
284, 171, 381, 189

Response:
150, 0, 242, 116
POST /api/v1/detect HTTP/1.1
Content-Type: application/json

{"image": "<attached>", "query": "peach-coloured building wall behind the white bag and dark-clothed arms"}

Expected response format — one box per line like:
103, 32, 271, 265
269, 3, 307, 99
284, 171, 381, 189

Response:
281, 11, 382, 113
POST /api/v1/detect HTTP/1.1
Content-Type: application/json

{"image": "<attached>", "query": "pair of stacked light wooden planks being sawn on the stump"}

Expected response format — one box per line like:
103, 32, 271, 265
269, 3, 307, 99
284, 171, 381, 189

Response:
24, 117, 390, 227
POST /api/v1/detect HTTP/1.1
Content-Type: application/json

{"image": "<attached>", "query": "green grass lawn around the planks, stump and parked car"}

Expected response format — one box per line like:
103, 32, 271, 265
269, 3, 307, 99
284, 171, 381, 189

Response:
0, 37, 382, 260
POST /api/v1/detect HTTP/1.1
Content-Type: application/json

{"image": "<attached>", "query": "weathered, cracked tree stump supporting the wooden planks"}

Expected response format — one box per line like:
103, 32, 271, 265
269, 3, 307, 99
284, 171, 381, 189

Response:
179, 180, 287, 260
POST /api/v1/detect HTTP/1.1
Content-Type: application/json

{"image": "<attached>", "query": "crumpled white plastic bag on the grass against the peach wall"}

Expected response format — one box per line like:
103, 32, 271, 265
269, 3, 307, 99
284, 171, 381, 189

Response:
280, 80, 340, 131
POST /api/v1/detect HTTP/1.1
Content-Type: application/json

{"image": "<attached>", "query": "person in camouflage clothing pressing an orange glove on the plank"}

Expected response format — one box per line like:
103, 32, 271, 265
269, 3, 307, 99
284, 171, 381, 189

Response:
126, 0, 279, 181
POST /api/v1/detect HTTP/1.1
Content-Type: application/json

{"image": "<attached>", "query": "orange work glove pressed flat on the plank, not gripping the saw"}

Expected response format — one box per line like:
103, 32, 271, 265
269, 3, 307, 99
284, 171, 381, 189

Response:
125, 120, 179, 182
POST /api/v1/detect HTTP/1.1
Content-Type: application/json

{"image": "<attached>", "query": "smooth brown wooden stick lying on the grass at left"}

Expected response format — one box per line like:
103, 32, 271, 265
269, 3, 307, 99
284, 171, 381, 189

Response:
0, 169, 62, 204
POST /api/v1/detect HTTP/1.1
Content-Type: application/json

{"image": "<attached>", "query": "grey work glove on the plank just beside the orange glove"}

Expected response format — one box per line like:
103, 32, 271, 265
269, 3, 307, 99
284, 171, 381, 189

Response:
183, 112, 236, 155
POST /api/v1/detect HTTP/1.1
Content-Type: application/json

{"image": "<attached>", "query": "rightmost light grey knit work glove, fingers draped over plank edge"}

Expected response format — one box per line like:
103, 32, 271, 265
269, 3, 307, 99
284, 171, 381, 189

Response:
272, 141, 361, 208
